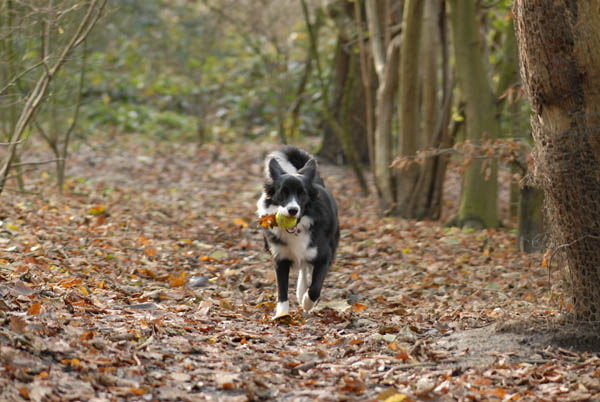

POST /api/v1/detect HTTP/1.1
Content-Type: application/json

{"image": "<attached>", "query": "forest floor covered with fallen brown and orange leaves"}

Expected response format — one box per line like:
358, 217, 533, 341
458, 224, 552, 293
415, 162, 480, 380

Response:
0, 136, 600, 402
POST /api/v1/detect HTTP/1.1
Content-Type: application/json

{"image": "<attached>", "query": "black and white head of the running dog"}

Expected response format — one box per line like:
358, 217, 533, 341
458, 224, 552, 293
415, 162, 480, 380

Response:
265, 159, 318, 219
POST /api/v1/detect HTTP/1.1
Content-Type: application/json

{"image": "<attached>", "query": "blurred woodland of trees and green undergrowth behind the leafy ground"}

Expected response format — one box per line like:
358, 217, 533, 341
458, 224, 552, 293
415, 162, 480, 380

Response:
0, 0, 543, 249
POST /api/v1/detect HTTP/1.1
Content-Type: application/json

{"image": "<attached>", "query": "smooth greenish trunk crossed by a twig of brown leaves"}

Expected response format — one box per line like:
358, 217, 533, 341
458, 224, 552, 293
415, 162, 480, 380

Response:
449, 0, 499, 229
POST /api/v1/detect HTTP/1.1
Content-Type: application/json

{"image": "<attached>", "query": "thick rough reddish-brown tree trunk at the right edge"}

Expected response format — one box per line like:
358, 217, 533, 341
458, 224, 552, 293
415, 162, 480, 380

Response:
513, 0, 600, 323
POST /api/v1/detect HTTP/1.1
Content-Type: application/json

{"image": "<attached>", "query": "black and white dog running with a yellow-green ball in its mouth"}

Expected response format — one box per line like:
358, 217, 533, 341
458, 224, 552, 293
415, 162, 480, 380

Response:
256, 146, 340, 317
